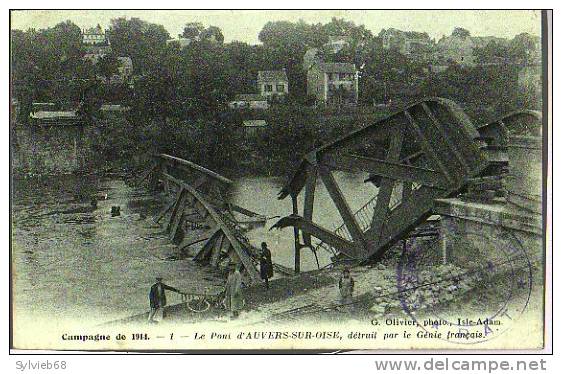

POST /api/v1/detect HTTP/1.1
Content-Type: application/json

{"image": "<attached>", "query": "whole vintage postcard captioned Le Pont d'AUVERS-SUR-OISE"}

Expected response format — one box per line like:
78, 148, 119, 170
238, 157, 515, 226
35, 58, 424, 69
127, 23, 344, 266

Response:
9, 10, 551, 352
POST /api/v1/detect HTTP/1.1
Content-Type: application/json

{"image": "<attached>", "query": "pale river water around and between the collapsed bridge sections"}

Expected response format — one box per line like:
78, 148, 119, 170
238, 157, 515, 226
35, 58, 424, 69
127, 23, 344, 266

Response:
12, 173, 376, 324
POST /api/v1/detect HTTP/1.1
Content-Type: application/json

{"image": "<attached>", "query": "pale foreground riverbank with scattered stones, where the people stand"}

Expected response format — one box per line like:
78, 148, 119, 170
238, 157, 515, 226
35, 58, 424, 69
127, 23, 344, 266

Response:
109, 248, 542, 328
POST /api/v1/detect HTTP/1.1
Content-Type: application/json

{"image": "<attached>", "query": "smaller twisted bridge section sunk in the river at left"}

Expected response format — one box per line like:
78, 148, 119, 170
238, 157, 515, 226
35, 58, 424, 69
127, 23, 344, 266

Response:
143, 154, 270, 283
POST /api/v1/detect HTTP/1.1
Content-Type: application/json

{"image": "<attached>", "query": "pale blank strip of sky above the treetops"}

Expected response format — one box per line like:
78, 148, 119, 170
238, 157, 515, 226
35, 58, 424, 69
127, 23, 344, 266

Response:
11, 10, 541, 44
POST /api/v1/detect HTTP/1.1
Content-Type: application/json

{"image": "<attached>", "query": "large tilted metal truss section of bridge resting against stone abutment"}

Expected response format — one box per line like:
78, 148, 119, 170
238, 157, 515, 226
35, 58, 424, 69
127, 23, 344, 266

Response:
274, 98, 540, 271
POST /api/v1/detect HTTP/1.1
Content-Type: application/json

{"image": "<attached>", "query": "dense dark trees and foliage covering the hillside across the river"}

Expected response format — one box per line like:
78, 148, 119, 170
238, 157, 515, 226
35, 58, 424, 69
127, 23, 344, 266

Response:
11, 18, 540, 173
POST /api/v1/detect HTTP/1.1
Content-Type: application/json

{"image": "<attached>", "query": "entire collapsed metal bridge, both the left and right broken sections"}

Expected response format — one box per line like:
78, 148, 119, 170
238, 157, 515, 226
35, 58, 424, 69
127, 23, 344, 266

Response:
139, 98, 541, 283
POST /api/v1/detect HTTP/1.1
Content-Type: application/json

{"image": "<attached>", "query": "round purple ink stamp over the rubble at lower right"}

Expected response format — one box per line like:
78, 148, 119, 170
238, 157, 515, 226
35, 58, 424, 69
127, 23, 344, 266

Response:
396, 231, 533, 344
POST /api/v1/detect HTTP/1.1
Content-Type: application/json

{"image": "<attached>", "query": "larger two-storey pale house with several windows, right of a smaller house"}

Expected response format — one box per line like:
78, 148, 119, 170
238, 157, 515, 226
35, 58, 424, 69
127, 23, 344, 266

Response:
306, 62, 359, 104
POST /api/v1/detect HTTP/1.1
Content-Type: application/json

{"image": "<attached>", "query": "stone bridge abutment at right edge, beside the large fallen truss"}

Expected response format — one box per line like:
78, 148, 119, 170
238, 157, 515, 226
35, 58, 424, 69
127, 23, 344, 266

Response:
434, 112, 544, 266
